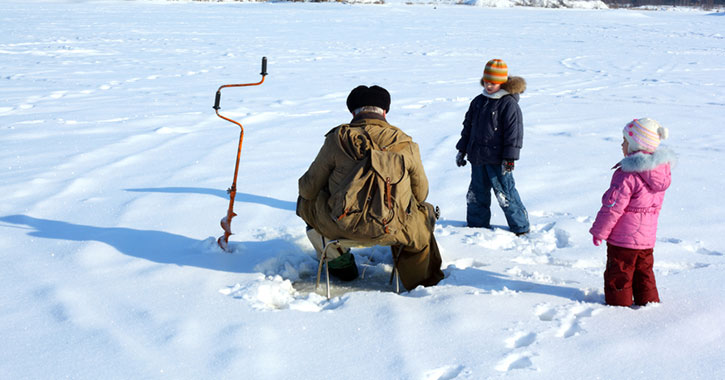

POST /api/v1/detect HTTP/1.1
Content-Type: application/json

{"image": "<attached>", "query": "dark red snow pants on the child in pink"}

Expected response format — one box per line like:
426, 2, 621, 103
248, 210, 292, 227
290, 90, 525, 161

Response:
604, 244, 660, 306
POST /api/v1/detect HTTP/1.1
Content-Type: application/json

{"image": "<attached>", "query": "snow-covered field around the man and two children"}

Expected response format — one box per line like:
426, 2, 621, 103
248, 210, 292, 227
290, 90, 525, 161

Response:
0, 0, 725, 380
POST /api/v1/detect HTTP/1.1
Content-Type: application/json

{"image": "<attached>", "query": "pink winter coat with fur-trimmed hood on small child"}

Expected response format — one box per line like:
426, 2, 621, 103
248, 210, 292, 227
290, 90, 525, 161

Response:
589, 147, 675, 249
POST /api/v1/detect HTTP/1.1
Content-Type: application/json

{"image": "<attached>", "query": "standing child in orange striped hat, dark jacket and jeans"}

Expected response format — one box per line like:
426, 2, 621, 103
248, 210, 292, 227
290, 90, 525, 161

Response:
456, 59, 529, 236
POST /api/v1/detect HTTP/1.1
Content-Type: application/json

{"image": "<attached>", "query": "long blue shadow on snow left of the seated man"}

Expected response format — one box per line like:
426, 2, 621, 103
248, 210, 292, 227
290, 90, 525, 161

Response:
0, 215, 302, 273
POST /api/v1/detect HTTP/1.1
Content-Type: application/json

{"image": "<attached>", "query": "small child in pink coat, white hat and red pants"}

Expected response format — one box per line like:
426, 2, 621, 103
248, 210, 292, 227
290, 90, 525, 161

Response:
589, 118, 675, 306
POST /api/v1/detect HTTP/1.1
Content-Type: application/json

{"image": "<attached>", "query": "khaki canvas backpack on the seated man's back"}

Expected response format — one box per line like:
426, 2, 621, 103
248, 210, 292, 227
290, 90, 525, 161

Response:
328, 124, 414, 239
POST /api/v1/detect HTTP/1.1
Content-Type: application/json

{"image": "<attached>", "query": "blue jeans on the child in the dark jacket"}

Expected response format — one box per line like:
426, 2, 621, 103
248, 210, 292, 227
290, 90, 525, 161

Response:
466, 165, 529, 234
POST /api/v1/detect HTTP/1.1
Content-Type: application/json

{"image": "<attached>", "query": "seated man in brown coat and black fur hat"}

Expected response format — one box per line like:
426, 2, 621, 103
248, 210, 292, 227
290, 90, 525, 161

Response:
297, 85, 443, 290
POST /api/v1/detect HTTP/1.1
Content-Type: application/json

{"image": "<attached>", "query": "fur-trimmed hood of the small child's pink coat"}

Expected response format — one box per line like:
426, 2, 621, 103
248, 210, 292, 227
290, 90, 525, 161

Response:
617, 147, 677, 191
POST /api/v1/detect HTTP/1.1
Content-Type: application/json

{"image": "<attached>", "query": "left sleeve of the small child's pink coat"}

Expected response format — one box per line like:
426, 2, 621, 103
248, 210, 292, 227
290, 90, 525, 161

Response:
589, 170, 634, 240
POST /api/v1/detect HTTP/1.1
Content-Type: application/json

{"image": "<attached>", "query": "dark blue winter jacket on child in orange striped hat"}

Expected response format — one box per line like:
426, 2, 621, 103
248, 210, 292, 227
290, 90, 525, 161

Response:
456, 77, 525, 165
